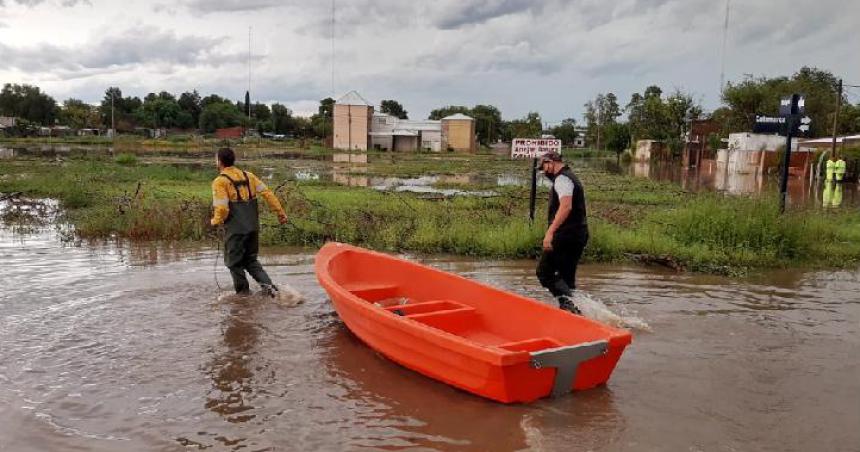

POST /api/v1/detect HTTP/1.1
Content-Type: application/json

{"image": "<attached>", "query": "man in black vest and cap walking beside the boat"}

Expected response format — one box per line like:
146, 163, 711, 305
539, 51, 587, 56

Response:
537, 152, 588, 314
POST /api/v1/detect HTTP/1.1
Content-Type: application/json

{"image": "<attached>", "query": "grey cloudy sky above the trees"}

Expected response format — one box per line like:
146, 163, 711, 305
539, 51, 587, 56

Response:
0, 0, 860, 122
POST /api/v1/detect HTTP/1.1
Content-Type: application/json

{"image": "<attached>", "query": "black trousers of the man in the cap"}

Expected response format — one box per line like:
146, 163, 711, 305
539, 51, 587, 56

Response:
537, 232, 588, 297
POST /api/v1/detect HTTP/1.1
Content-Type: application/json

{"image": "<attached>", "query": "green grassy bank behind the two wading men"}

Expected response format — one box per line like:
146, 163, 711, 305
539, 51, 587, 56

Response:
0, 156, 860, 274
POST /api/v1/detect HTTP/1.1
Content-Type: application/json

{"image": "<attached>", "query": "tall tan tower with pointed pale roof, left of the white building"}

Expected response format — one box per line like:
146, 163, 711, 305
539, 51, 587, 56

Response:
332, 91, 373, 151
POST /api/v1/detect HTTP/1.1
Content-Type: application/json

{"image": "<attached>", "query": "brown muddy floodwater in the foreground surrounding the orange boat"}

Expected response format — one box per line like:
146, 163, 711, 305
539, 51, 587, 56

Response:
0, 201, 860, 451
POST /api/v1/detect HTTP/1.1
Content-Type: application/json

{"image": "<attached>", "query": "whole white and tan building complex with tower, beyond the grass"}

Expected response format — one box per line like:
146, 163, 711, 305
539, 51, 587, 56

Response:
332, 91, 478, 152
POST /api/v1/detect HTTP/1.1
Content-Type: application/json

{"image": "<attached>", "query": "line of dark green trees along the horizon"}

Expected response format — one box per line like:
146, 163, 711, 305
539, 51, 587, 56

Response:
0, 67, 860, 145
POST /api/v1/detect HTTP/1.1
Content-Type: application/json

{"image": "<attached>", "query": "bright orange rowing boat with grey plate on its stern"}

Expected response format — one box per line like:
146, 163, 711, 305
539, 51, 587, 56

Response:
315, 243, 631, 403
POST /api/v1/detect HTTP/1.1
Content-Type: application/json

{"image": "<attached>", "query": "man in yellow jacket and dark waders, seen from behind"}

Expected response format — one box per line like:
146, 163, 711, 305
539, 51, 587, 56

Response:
212, 148, 287, 297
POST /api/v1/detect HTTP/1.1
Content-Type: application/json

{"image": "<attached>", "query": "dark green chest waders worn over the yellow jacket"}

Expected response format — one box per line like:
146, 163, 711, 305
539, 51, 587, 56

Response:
221, 171, 277, 293
